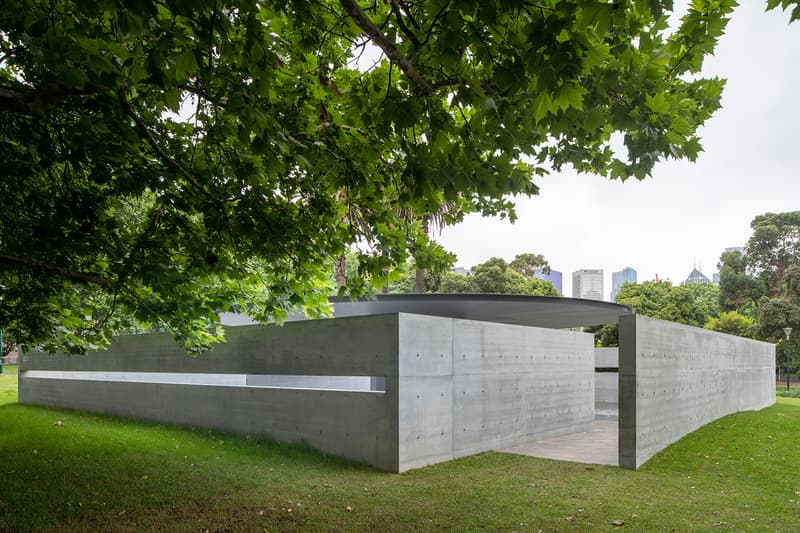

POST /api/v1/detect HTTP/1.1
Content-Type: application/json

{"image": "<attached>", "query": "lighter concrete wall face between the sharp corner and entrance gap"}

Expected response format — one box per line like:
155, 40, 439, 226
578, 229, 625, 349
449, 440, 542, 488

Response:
398, 315, 594, 468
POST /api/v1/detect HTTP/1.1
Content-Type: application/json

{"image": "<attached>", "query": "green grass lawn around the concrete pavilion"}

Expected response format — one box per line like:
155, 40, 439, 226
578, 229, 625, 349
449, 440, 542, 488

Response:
0, 375, 800, 532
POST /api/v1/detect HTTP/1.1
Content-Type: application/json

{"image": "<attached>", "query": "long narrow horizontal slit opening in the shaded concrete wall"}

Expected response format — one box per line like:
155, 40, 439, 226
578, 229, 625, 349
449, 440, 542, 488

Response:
20, 370, 386, 393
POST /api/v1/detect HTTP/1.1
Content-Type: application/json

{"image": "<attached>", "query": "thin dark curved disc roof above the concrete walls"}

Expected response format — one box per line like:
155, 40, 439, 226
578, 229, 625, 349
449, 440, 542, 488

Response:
330, 294, 633, 328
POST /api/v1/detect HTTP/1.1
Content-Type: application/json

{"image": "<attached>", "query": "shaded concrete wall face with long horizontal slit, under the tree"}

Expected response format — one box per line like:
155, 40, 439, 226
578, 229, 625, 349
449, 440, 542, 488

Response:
19, 315, 399, 471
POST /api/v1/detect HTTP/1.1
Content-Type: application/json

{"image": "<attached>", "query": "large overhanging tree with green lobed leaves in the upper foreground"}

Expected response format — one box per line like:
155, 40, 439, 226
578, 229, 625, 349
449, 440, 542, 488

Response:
0, 0, 740, 351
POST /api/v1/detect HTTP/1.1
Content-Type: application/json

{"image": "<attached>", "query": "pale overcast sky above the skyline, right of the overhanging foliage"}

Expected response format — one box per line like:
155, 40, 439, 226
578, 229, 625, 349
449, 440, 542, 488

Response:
436, 0, 800, 299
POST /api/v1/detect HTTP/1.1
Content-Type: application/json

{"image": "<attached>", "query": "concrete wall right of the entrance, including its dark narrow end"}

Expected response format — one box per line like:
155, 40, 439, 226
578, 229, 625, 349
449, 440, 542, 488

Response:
619, 315, 775, 468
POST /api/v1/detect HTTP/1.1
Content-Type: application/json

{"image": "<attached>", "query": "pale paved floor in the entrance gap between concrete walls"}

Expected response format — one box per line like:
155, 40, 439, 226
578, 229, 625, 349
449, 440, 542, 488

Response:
498, 419, 619, 466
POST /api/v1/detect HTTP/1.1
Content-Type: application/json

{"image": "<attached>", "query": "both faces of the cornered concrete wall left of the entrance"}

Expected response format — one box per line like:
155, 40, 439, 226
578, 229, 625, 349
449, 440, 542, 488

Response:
20, 313, 594, 471
